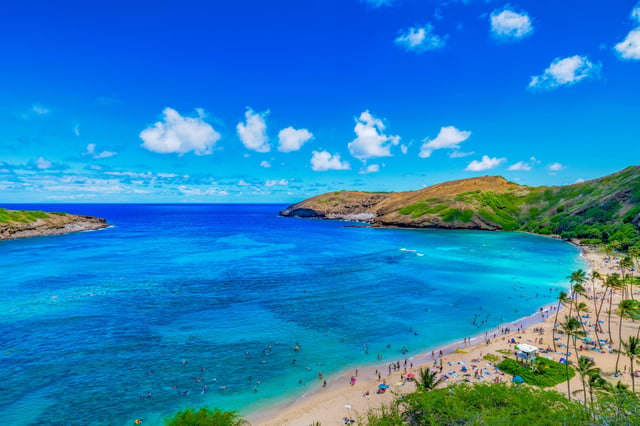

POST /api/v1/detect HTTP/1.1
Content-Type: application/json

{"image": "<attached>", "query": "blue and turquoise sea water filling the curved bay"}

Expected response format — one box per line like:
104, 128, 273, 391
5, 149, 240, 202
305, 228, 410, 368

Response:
0, 204, 585, 425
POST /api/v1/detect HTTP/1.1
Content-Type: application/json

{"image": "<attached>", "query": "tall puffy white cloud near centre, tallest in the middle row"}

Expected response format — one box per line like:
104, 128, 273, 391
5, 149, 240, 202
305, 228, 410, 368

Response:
348, 111, 400, 161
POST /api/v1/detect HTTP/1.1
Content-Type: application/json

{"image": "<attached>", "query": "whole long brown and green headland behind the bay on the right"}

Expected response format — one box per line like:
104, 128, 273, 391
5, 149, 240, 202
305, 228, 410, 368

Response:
280, 166, 640, 249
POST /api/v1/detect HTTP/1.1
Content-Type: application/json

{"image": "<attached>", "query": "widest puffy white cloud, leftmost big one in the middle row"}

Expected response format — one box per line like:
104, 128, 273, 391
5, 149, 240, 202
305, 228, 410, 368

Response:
140, 108, 220, 155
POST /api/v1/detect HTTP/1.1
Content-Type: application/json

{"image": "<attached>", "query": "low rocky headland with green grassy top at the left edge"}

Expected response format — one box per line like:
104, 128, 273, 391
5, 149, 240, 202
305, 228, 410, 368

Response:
0, 209, 109, 240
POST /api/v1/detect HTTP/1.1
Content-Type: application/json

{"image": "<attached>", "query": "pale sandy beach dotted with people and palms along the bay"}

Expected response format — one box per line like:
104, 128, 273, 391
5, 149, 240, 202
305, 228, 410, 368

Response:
247, 248, 638, 426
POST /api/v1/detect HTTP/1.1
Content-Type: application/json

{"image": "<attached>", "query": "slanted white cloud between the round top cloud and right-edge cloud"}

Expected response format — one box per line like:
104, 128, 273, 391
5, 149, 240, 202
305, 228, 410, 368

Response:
529, 55, 601, 90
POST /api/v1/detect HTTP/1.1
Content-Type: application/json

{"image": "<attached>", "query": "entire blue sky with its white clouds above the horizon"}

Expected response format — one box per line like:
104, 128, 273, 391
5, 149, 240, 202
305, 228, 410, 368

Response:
0, 0, 640, 203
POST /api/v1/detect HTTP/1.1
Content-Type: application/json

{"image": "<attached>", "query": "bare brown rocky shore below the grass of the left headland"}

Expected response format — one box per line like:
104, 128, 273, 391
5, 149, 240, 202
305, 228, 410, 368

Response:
0, 213, 109, 241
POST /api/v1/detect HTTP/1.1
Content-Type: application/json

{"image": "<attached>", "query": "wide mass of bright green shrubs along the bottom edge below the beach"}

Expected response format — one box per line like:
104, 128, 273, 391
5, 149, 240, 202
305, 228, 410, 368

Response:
395, 383, 589, 426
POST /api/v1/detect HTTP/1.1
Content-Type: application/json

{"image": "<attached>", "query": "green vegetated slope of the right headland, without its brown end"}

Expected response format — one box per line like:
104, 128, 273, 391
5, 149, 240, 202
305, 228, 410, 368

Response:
398, 166, 640, 249
